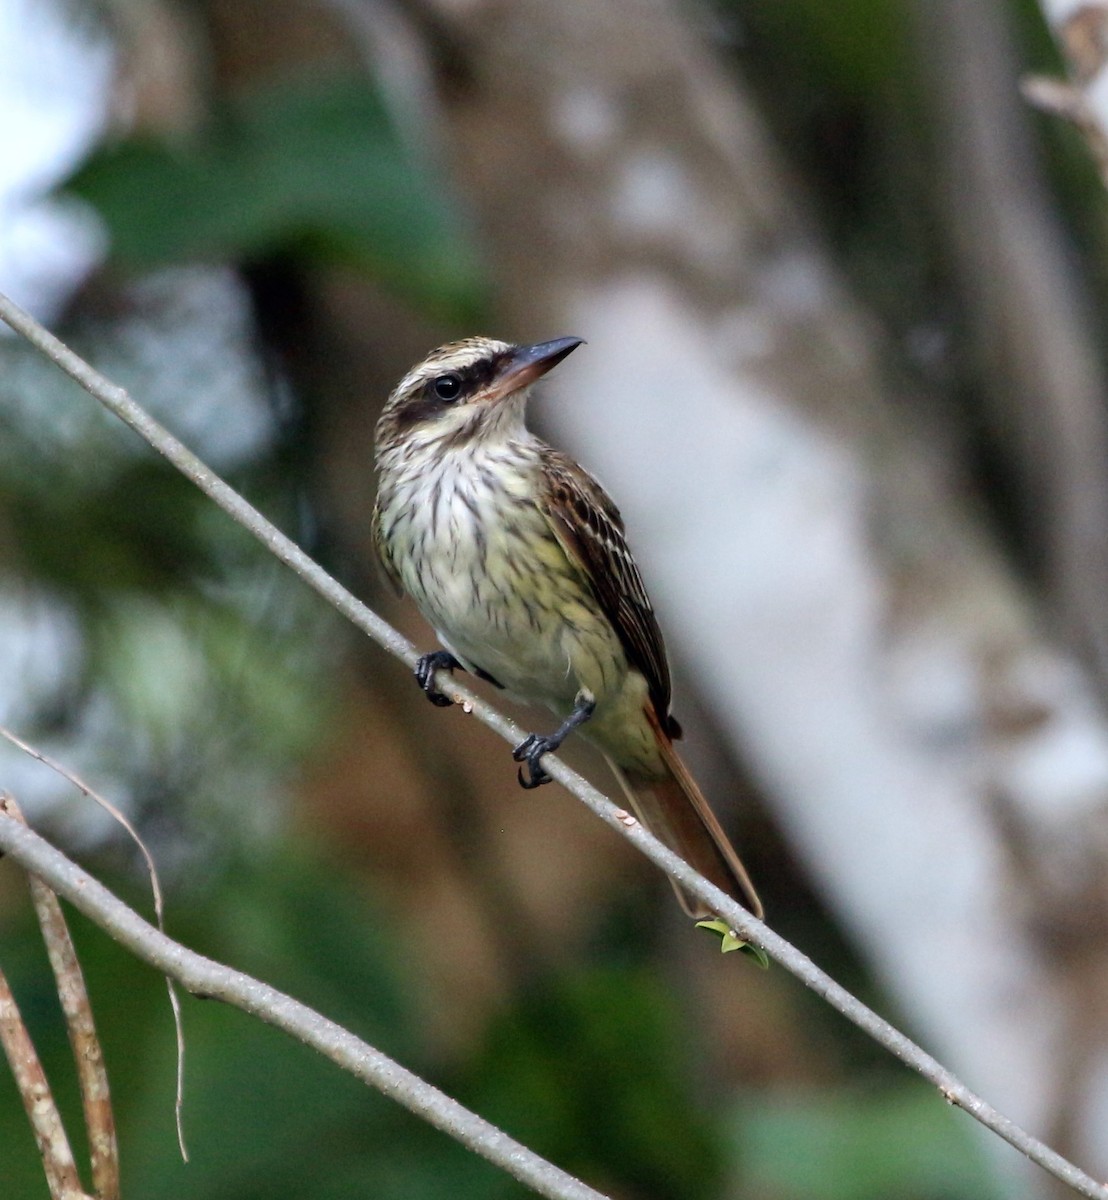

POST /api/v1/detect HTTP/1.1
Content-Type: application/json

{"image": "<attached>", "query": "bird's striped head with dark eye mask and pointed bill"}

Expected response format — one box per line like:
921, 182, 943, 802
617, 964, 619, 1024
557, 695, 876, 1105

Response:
377, 337, 582, 456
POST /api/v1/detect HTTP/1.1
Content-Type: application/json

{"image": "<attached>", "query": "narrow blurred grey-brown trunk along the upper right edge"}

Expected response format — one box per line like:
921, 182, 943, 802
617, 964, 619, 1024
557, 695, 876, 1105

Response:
914, 0, 1108, 694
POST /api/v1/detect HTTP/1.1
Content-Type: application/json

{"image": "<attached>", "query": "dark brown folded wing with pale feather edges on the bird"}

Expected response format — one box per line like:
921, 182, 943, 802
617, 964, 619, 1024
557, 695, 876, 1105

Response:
543, 446, 678, 715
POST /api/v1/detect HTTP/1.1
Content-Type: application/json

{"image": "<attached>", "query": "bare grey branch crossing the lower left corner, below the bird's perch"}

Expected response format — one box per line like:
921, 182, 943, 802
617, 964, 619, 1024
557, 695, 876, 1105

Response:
0, 814, 606, 1200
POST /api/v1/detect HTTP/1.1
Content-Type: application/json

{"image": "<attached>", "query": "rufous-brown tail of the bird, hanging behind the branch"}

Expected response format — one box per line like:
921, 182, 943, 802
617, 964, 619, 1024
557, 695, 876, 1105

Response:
609, 712, 765, 920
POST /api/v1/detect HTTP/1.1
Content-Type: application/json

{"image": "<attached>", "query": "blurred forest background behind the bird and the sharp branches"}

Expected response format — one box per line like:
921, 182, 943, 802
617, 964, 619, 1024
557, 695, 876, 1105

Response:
0, 0, 1108, 1200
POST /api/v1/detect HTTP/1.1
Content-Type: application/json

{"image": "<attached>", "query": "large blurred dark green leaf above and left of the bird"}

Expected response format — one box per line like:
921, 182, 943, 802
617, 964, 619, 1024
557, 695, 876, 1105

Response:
65, 73, 481, 319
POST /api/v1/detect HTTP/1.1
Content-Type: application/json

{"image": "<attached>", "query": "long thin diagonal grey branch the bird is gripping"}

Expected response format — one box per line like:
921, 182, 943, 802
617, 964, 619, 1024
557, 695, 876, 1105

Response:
0, 295, 1108, 1200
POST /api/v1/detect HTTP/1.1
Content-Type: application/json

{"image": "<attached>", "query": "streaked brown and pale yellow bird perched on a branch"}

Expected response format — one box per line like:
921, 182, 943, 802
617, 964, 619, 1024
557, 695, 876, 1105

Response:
372, 337, 763, 920
